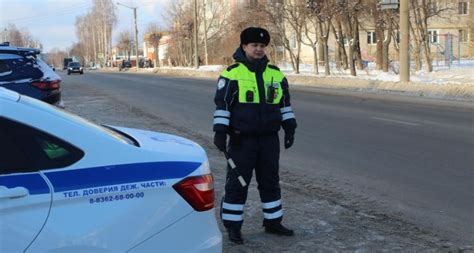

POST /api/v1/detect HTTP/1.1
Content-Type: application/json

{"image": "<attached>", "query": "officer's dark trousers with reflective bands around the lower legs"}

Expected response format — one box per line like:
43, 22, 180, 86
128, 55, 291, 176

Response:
221, 133, 283, 229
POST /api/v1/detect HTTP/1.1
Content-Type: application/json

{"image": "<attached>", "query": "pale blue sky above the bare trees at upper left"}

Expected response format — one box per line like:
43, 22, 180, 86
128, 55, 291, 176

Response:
0, 0, 172, 52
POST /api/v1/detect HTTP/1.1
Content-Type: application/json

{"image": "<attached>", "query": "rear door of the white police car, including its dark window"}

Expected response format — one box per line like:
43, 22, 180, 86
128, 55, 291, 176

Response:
0, 115, 84, 252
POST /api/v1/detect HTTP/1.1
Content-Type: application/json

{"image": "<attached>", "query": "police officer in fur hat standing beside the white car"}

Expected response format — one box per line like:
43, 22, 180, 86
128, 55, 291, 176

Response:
214, 27, 296, 244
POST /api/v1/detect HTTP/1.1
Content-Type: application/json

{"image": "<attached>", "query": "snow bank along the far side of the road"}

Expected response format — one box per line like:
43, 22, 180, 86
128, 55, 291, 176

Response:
102, 59, 474, 101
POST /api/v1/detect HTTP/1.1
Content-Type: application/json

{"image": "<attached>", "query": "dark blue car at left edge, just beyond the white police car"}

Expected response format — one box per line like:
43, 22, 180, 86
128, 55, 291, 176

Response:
0, 43, 63, 107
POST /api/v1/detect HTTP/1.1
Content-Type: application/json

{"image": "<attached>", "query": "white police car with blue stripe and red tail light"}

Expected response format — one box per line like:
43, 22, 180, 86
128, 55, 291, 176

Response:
0, 88, 222, 252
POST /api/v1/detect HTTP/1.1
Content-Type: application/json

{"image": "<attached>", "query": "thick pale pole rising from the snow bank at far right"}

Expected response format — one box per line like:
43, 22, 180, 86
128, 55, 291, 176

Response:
400, 0, 410, 82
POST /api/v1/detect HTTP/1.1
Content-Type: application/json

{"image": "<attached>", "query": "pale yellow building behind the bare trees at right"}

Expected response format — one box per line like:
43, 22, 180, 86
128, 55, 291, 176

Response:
286, 0, 474, 68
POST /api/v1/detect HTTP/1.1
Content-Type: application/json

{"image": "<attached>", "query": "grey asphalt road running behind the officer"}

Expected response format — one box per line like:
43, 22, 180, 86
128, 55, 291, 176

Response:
60, 72, 474, 243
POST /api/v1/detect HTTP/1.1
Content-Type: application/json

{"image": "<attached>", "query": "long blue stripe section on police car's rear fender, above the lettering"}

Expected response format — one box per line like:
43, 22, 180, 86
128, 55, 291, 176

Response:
45, 162, 201, 192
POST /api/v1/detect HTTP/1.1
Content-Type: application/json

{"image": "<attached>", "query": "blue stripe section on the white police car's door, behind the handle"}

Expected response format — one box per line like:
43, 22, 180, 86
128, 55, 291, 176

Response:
0, 173, 50, 195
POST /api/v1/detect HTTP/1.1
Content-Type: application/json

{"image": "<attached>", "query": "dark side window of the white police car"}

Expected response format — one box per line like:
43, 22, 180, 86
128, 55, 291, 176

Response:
0, 117, 84, 174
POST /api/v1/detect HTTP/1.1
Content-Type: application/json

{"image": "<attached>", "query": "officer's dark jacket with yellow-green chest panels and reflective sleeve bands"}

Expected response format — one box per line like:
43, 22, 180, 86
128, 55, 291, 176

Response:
214, 63, 296, 134
